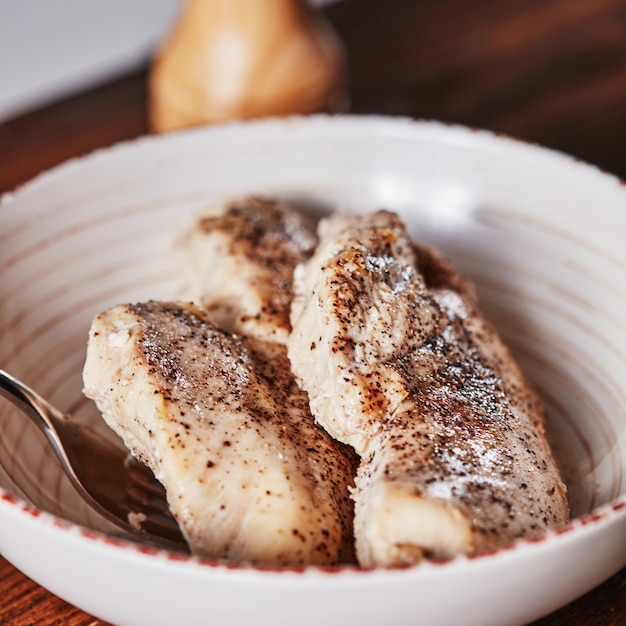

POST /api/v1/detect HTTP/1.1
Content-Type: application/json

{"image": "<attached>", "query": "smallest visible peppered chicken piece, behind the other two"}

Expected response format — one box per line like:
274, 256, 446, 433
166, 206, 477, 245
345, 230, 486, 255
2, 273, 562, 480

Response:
179, 197, 316, 343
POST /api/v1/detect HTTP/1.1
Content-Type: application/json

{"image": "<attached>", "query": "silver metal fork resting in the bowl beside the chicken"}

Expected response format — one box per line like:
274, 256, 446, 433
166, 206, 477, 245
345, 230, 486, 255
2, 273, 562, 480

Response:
0, 369, 188, 551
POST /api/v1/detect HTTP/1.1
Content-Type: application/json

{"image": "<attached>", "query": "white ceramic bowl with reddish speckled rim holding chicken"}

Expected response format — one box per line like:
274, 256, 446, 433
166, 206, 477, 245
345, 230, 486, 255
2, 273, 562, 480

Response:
0, 117, 626, 626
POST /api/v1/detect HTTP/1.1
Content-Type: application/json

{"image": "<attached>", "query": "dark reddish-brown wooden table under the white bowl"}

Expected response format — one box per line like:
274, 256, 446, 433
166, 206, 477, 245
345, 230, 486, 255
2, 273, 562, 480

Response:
0, 0, 626, 626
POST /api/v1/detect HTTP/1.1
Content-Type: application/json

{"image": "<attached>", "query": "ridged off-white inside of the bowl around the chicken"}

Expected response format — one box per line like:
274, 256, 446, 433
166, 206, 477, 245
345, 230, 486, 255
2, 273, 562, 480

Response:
0, 117, 626, 624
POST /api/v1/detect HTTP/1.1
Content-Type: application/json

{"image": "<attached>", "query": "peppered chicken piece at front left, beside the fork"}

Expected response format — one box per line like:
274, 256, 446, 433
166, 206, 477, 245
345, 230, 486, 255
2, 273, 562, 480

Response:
83, 302, 354, 565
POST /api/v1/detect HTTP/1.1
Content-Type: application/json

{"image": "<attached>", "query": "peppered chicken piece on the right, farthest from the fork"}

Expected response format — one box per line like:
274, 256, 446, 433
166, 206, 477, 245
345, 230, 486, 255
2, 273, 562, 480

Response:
288, 211, 569, 566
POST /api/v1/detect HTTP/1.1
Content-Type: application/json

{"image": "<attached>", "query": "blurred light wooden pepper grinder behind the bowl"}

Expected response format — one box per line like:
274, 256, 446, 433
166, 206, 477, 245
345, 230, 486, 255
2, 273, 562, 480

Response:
149, 0, 346, 132
